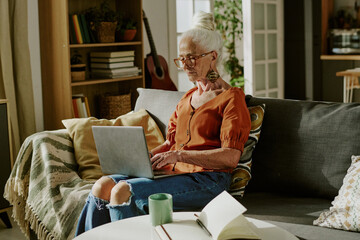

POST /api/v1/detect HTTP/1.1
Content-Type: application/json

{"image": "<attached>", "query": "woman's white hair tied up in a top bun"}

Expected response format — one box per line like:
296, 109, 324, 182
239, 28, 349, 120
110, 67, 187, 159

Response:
181, 11, 223, 65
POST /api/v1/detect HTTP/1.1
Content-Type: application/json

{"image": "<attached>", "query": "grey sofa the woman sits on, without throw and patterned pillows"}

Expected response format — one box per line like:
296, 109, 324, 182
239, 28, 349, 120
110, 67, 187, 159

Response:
135, 89, 360, 240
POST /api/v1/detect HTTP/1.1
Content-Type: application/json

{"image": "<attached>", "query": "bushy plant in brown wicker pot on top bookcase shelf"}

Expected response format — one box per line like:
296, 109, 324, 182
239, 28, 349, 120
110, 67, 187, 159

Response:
85, 0, 122, 43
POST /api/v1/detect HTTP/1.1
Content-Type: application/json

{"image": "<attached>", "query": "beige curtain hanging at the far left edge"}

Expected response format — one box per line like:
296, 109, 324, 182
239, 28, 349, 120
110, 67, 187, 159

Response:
0, 0, 36, 159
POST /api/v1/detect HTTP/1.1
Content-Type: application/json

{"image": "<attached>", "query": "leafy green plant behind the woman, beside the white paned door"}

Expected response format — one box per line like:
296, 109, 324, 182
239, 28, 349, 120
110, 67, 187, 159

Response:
214, 0, 244, 88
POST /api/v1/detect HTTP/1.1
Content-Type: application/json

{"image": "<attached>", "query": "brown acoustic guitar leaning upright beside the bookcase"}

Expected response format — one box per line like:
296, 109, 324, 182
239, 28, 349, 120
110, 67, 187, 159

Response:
143, 10, 177, 91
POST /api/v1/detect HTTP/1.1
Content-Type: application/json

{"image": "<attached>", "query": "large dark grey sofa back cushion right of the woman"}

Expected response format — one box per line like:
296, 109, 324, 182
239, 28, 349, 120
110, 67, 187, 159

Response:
247, 96, 360, 199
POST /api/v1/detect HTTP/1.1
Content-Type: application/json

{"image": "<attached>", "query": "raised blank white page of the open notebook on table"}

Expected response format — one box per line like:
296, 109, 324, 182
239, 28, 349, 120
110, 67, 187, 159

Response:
199, 191, 246, 239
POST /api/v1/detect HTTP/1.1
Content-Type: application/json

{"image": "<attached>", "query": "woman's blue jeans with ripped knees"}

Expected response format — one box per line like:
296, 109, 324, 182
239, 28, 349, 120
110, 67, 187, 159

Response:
75, 172, 231, 236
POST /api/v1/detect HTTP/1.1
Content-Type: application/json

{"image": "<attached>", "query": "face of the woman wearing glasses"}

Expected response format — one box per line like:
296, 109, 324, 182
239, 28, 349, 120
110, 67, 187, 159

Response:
179, 37, 216, 83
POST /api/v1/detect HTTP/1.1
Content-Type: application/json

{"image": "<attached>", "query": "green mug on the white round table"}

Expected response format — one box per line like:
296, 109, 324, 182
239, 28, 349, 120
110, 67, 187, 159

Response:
149, 193, 173, 226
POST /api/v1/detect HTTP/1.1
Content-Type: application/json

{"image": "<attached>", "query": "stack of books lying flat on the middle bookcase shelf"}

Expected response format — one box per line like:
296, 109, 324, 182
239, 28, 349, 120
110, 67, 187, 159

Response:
90, 50, 141, 78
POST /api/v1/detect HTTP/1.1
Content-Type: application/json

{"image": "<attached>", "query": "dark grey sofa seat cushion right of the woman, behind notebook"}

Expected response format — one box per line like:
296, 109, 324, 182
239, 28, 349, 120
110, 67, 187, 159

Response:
239, 193, 359, 240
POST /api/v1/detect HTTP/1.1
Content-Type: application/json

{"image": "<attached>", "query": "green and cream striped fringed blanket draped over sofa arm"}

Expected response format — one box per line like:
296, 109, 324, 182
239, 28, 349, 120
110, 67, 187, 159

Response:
4, 130, 93, 239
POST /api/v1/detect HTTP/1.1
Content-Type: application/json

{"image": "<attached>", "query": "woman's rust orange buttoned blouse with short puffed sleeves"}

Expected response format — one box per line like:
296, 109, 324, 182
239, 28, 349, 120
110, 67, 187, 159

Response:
166, 87, 251, 172
